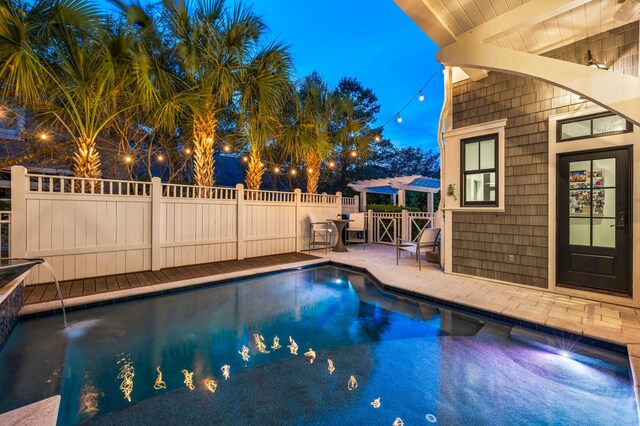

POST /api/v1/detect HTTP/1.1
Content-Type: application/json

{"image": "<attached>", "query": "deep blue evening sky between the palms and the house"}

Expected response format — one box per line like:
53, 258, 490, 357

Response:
250, 0, 443, 150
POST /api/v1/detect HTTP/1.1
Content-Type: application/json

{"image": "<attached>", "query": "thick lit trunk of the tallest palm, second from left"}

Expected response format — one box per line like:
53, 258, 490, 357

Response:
193, 114, 216, 186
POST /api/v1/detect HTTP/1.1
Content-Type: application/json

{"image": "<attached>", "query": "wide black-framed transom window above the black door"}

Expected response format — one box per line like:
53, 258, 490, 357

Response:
556, 112, 633, 142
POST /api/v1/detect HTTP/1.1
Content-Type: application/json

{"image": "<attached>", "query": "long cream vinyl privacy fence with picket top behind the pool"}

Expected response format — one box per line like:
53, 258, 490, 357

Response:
3, 166, 342, 283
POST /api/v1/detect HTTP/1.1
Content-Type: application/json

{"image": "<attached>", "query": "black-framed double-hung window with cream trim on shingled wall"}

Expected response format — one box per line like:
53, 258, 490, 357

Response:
460, 134, 498, 207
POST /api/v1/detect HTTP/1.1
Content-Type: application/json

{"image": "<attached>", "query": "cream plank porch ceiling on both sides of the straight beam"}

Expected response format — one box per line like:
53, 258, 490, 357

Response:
395, 0, 628, 78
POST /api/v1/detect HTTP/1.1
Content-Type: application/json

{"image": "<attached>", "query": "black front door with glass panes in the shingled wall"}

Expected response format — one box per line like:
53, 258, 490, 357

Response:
557, 148, 632, 295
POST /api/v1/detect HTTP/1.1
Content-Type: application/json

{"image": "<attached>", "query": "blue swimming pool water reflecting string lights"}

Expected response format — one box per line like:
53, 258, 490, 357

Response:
0, 267, 638, 426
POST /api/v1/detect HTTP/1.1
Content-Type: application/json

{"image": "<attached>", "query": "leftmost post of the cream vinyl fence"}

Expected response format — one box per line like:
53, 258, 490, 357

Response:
9, 166, 29, 257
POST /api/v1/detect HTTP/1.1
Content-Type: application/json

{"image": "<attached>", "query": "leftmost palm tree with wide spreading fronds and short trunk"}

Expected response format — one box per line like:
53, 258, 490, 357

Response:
0, 0, 153, 178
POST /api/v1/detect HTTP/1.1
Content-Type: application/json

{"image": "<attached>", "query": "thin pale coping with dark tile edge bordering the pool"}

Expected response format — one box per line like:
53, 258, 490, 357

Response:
12, 258, 640, 417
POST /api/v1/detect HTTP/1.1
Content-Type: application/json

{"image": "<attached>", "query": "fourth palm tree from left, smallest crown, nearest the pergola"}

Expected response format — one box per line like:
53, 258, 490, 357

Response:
283, 72, 333, 194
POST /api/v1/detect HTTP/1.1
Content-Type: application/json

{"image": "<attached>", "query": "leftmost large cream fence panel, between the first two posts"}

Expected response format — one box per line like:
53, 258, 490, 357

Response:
24, 175, 151, 283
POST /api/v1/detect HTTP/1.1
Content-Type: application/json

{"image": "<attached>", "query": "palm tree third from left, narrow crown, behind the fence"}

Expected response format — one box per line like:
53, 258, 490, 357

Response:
240, 43, 291, 189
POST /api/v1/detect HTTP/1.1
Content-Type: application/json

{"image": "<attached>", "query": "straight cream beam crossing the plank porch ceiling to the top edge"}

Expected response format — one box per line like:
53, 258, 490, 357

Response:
458, 0, 591, 47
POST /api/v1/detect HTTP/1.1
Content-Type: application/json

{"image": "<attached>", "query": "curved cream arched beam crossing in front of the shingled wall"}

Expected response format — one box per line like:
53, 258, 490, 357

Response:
436, 42, 640, 126
